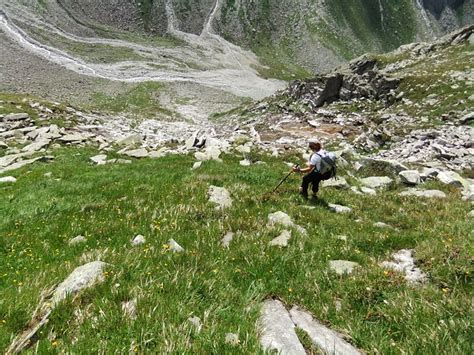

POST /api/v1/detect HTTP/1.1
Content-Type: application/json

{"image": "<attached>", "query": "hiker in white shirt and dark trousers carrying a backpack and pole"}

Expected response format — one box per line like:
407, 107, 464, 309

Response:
293, 141, 335, 198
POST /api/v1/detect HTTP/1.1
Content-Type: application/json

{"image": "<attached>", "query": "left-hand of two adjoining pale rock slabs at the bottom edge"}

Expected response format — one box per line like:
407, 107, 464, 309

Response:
259, 300, 306, 355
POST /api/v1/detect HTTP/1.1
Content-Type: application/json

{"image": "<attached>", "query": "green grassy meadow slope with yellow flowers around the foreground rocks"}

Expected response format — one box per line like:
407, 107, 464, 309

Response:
0, 148, 473, 353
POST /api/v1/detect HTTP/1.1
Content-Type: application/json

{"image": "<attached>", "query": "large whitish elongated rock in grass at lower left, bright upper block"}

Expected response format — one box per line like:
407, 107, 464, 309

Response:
51, 261, 107, 307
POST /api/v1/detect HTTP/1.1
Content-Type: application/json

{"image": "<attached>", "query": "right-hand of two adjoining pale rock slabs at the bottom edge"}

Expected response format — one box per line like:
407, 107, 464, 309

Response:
290, 307, 362, 355
